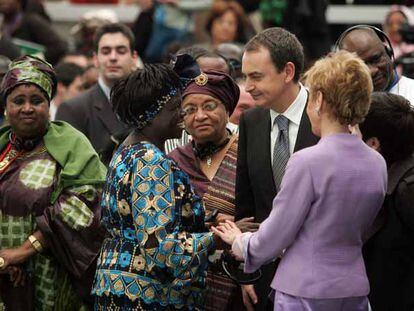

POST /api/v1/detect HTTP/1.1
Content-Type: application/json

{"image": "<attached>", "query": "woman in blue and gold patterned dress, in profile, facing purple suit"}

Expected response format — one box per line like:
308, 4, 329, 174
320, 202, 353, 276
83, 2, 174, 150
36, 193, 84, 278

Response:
93, 64, 215, 310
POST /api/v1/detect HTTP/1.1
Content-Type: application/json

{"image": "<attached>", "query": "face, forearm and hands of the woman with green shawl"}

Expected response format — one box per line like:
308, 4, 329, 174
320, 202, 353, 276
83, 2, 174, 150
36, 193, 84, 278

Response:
0, 84, 49, 286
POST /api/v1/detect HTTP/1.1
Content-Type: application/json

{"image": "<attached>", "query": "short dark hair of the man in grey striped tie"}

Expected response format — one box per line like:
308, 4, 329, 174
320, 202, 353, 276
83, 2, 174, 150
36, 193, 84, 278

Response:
245, 27, 305, 82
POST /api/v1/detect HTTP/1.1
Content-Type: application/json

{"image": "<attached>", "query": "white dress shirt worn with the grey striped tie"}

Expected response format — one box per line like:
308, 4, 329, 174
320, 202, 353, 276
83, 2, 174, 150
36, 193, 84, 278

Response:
270, 83, 308, 163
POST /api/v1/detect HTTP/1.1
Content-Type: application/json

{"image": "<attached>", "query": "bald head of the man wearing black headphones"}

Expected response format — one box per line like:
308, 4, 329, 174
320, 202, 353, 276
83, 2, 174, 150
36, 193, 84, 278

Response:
339, 28, 394, 91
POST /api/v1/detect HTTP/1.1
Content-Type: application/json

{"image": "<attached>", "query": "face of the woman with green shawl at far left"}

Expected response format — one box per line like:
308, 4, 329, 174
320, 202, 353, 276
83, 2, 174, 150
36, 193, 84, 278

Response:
6, 84, 49, 138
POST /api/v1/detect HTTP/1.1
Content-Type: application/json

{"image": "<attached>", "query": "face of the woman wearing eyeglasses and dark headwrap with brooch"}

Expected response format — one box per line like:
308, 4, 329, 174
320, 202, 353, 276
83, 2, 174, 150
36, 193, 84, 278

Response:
181, 94, 228, 144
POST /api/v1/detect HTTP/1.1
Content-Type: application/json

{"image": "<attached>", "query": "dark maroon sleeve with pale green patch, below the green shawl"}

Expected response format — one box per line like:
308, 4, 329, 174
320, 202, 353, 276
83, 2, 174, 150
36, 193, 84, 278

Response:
36, 185, 104, 278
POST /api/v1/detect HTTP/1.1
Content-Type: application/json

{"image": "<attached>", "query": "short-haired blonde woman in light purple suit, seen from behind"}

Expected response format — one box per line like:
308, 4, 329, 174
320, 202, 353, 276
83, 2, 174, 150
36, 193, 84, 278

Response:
213, 51, 387, 311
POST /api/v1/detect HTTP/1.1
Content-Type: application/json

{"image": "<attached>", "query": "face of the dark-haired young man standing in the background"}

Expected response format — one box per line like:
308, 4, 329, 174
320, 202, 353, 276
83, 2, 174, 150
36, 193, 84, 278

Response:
94, 32, 137, 86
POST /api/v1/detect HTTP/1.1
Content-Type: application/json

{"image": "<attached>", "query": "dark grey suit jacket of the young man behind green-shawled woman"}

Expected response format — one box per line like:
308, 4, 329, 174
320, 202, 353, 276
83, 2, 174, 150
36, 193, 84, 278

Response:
56, 84, 127, 153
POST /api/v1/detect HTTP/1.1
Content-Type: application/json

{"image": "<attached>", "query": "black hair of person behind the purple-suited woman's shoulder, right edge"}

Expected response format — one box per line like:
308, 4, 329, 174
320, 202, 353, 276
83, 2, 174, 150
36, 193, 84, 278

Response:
359, 92, 414, 166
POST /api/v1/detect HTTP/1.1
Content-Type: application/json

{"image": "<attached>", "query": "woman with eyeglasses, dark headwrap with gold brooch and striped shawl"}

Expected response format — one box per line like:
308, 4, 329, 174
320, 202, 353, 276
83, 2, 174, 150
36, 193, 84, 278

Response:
169, 71, 256, 310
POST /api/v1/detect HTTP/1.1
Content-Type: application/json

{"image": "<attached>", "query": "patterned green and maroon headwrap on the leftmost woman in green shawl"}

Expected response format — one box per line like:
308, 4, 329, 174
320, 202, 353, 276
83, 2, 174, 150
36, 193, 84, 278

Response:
1, 55, 57, 102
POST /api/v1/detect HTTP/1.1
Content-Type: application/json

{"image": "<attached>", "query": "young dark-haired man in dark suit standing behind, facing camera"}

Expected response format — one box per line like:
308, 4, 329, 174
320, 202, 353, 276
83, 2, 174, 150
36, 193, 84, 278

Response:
56, 23, 137, 161
